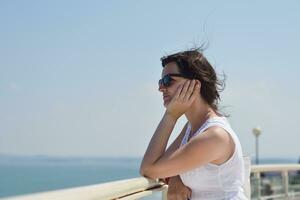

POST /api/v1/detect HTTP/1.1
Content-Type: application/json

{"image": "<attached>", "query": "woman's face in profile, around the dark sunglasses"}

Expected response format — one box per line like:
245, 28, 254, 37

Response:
158, 62, 186, 106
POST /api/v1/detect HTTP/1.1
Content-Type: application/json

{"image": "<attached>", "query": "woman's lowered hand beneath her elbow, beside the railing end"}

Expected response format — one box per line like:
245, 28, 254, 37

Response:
167, 176, 192, 200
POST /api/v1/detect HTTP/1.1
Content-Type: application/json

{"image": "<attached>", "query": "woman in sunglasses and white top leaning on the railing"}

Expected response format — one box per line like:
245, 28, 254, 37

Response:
140, 49, 246, 200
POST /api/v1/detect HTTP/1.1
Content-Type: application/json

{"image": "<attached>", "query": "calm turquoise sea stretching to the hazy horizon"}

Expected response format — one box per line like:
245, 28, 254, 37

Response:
0, 154, 297, 199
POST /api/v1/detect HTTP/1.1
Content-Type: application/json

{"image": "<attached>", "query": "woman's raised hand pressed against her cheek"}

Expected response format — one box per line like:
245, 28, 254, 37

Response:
166, 80, 200, 120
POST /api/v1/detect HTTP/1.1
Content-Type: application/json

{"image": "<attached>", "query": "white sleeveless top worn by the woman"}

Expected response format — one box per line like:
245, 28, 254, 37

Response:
179, 117, 247, 200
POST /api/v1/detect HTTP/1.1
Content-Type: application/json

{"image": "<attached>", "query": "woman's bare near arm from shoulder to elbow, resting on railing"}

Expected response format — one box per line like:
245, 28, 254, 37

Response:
140, 127, 232, 179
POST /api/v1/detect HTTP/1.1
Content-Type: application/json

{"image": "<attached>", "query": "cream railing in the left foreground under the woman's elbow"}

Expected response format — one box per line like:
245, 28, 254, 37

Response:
1, 177, 168, 200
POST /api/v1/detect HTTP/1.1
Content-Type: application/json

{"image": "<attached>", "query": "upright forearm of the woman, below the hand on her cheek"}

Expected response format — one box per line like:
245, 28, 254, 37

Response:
141, 112, 177, 170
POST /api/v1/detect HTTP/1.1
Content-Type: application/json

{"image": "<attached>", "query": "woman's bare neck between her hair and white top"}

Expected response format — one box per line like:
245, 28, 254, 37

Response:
185, 99, 218, 133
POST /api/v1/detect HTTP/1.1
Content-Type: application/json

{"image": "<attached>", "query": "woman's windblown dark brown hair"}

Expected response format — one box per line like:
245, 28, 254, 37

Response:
160, 47, 225, 111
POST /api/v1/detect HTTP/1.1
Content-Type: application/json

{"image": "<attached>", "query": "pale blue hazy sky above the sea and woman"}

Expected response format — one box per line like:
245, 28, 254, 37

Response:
0, 0, 300, 158
